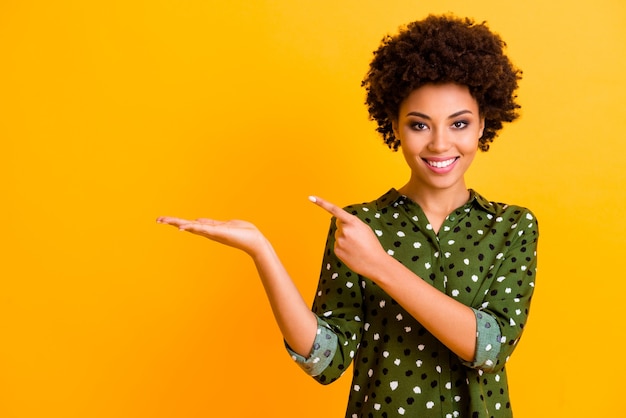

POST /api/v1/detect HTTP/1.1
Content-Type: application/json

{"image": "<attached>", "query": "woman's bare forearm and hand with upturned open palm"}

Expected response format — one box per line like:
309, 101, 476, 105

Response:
157, 217, 317, 357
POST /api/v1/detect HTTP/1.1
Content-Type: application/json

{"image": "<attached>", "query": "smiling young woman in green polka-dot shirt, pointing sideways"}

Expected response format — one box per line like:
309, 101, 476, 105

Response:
158, 16, 538, 417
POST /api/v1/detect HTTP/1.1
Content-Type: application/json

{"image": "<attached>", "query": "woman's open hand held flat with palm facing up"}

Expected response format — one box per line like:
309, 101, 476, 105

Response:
157, 216, 266, 256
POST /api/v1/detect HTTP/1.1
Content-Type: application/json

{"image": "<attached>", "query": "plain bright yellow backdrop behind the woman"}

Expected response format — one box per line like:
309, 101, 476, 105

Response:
0, 0, 626, 418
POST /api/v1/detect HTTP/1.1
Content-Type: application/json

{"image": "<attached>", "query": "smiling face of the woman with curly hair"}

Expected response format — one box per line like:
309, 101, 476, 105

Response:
393, 83, 485, 198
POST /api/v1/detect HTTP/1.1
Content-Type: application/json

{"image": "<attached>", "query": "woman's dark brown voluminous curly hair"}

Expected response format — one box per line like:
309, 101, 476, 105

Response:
361, 15, 522, 151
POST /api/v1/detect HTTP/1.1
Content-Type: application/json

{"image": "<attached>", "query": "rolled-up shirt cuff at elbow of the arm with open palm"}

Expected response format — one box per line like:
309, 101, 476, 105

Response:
285, 317, 337, 376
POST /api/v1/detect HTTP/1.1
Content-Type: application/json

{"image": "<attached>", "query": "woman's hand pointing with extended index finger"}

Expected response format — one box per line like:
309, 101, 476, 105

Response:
309, 196, 389, 280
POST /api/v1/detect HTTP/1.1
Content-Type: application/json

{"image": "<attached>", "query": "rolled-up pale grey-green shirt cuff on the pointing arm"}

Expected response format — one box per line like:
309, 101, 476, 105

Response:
464, 308, 502, 371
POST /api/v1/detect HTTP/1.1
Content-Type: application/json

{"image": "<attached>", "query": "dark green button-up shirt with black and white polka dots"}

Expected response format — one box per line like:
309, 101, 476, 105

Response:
287, 189, 538, 418
